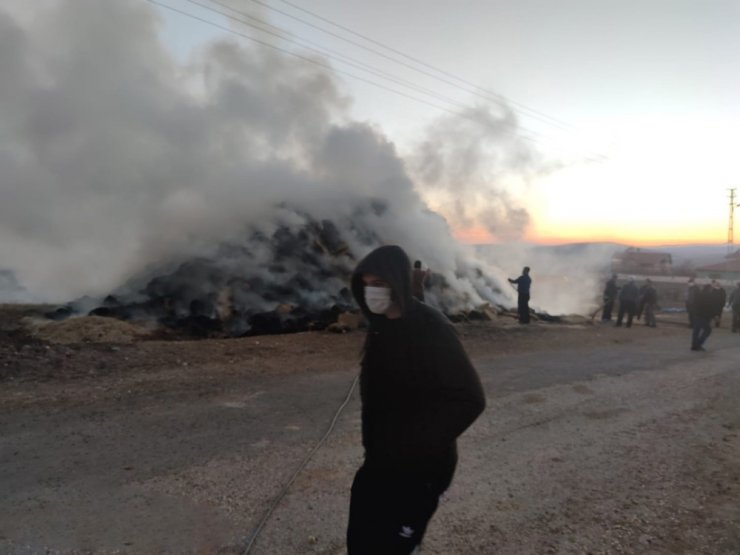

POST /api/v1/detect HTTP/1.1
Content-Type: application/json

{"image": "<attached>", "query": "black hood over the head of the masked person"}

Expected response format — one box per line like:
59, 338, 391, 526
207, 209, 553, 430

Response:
352, 245, 413, 322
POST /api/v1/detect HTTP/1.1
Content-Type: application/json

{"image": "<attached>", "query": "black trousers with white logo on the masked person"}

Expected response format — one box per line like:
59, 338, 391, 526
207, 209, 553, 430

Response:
347, 466, 449, 555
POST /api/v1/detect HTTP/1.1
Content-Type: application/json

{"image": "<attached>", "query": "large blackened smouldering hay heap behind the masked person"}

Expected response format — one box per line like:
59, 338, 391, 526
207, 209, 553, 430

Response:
42, 208, 528, 337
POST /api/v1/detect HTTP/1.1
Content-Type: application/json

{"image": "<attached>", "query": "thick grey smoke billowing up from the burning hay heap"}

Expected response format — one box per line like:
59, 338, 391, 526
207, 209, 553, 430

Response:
0, 0, 600, 318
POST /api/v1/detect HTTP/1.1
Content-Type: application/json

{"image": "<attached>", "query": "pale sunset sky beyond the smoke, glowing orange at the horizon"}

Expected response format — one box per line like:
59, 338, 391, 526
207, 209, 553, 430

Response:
160, 0, 740, 245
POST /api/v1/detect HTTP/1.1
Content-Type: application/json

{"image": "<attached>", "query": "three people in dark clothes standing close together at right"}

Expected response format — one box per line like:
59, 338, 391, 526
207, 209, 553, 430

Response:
601, 274, 658, 328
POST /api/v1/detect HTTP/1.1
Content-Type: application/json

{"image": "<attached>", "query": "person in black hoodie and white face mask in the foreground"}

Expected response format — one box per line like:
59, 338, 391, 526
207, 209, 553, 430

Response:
347, 246, 485, 555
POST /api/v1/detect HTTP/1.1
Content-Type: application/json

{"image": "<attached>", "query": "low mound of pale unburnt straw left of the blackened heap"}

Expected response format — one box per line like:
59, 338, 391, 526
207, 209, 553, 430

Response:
24, 316, 150, 344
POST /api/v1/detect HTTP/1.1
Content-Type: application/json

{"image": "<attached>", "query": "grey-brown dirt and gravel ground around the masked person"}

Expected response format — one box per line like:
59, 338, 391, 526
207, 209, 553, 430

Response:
0, 306, 740, 554
